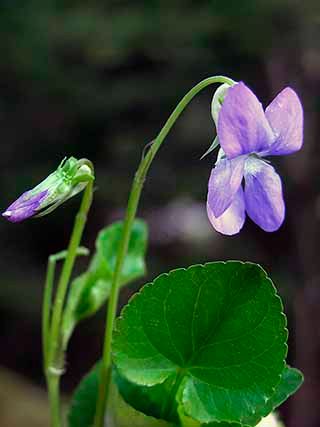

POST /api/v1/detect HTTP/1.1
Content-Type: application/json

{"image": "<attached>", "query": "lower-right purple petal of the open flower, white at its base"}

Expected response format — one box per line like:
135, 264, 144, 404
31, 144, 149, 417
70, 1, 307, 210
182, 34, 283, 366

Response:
244, 158, 285, 231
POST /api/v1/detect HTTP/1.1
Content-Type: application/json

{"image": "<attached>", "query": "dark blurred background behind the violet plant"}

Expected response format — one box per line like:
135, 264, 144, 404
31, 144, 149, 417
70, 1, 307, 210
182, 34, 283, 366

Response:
0, 0, 320, 427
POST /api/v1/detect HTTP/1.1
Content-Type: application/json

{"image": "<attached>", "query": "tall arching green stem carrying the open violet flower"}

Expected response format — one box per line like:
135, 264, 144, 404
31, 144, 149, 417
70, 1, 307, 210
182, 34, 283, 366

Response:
94, 76, 235, 427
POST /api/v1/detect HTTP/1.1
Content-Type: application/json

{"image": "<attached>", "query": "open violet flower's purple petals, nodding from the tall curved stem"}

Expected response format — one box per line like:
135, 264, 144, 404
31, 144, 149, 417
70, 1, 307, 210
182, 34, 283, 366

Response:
207, 82, 303, 235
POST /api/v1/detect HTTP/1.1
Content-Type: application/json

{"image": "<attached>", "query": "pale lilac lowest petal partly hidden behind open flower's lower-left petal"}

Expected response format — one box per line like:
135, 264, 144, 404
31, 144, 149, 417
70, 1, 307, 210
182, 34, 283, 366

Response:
207, 186, 246, 236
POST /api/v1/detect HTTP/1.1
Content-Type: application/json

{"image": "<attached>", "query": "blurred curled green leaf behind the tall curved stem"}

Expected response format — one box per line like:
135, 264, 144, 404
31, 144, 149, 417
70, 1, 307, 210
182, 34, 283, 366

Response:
62, 220, 148, 348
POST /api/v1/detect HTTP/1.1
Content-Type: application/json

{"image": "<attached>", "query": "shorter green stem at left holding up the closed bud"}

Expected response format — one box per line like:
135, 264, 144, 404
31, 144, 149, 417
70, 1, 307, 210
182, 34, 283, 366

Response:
43, 181, 93, 427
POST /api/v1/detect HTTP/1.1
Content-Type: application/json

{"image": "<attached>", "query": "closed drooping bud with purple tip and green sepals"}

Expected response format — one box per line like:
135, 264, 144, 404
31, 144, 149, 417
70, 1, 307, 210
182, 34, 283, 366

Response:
2, 157, 94, 222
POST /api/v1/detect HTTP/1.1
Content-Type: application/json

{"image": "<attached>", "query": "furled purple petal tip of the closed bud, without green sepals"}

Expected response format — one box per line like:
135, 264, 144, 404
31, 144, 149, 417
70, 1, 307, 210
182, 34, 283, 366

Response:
2, 190, 48, 222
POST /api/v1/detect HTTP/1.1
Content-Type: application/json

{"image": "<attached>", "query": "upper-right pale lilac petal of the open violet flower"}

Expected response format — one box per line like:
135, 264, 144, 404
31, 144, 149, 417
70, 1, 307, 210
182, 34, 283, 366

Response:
266, 87, 303, 155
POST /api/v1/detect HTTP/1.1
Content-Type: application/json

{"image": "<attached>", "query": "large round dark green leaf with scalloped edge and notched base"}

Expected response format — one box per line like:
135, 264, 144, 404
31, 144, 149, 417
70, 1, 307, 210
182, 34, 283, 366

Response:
113, 262, 287, 424
